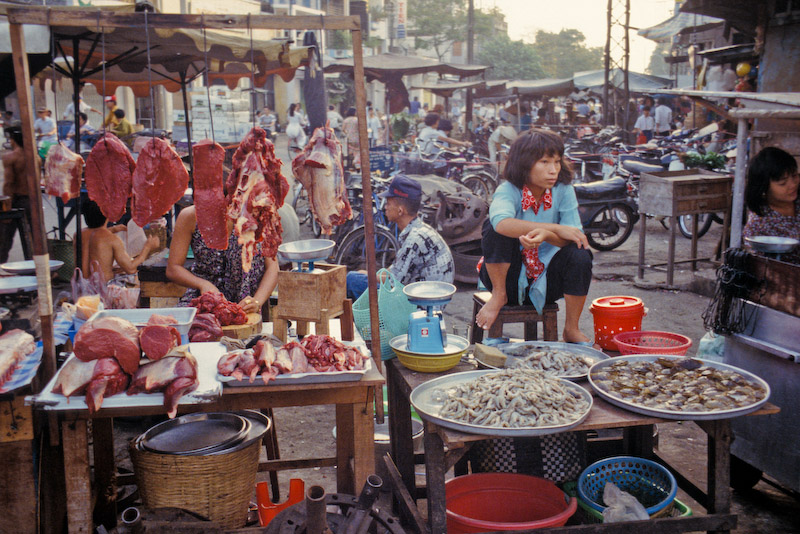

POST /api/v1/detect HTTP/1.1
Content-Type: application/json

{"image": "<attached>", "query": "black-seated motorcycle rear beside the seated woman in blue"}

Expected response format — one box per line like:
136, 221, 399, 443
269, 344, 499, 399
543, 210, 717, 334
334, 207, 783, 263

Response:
573, 176, 639, 251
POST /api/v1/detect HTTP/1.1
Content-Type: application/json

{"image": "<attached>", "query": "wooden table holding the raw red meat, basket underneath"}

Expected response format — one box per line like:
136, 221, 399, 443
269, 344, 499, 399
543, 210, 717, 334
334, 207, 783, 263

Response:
53, 348, 384, 534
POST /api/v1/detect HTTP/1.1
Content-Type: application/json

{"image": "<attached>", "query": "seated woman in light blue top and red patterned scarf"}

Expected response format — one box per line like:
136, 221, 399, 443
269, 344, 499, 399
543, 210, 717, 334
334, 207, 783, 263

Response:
476, 129, 592, 346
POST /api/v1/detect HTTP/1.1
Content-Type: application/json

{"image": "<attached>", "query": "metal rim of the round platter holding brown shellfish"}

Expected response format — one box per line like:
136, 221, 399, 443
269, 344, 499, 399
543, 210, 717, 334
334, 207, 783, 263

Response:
589, 354, 770, 421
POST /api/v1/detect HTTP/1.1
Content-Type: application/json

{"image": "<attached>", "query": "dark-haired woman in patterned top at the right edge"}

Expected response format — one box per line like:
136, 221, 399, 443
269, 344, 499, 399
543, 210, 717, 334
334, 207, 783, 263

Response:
742, 147, 800, 263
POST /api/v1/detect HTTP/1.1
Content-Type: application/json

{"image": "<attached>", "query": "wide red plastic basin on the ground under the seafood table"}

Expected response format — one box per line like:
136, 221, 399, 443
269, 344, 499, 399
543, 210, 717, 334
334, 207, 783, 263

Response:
445, 473, 578, 534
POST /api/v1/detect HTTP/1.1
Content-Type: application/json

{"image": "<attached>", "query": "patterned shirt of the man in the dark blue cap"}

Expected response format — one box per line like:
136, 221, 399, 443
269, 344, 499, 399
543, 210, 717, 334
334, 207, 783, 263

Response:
389, 217, 456, 285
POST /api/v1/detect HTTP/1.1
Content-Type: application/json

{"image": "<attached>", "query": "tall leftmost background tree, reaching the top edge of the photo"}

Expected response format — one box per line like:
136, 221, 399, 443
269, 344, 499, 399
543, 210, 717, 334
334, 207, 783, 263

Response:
408, 0, 467, 61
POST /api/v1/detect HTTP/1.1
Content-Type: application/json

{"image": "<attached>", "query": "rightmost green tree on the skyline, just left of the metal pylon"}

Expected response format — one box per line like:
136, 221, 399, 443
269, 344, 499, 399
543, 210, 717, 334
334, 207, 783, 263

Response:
533, 29, 603, 78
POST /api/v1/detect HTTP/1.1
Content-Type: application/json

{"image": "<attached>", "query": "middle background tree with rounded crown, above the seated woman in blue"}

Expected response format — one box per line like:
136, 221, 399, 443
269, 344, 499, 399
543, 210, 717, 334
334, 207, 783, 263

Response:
477, 34, 545, 80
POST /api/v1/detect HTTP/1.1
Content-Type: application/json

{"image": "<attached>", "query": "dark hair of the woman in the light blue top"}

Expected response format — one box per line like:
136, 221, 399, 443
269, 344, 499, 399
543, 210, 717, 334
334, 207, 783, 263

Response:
503, 128, 572, 189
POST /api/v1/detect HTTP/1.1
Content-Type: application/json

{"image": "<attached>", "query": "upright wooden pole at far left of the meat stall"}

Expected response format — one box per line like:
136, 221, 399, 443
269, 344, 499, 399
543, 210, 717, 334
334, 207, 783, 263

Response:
9, 23, 56, 384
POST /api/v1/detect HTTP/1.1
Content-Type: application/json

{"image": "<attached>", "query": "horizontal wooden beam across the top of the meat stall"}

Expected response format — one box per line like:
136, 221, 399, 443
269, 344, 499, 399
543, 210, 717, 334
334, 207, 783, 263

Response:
0, 7, 361, 30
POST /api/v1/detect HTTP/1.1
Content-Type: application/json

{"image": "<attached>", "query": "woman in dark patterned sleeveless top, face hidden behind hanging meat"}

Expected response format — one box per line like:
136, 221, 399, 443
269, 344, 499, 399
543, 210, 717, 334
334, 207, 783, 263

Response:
167, 206, 278, 313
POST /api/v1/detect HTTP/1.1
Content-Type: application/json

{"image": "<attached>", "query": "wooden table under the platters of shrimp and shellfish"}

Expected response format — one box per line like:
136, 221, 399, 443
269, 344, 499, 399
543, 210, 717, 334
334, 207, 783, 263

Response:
384, 359, 779, 534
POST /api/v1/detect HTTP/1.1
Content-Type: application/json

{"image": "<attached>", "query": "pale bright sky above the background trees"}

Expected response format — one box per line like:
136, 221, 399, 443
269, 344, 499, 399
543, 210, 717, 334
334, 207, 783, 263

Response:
482, 0, 675, 72
